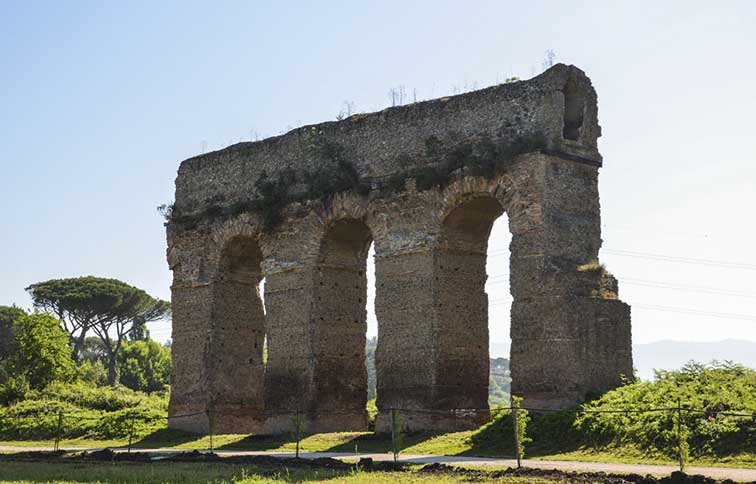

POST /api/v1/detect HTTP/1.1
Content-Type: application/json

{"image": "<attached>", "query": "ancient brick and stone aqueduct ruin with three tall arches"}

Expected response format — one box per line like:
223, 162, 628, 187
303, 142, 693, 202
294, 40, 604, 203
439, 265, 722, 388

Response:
167, 65, 632, 433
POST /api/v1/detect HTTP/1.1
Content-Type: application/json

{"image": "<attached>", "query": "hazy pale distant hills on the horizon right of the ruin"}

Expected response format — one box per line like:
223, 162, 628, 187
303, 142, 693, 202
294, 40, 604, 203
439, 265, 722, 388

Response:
491, 339, 756, 380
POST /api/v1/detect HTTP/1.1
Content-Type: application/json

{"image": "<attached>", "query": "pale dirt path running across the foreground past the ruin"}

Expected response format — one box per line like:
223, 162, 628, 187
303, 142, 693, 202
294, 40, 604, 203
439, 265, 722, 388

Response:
0, 446, 756, 482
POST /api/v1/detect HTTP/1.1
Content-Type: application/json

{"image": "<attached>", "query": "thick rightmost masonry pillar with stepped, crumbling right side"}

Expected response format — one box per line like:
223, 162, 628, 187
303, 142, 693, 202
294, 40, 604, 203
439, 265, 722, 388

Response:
510, 155, 633, 408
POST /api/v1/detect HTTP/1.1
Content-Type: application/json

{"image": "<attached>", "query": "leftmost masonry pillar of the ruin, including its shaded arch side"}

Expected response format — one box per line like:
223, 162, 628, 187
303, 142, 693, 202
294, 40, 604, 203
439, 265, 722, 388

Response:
169, 231, 265, 433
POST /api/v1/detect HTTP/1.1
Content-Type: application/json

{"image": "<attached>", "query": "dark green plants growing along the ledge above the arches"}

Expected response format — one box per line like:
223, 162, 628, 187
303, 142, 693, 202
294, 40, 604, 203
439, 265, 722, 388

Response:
158, 133, 547, 230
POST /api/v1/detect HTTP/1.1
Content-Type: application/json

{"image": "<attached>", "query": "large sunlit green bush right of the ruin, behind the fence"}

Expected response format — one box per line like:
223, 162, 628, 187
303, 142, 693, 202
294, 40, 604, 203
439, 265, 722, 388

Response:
575, 362, 756, 457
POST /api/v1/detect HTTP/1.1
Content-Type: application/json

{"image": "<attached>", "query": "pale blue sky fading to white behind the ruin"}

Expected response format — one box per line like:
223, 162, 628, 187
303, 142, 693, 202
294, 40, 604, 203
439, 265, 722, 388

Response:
0, 0, 756, 342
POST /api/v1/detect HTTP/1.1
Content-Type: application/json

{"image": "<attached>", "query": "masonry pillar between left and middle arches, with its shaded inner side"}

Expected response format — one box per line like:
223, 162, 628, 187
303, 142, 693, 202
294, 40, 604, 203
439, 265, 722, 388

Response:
266, 219, 371, 433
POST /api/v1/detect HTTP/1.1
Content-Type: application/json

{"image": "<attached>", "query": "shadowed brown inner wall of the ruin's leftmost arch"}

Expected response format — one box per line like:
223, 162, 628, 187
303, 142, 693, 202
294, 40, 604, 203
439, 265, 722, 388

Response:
208, 237, 265, 433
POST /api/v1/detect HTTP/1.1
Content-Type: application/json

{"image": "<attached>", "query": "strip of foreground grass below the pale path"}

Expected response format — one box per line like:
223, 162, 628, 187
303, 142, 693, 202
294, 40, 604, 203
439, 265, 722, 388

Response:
0, 462, 585, 484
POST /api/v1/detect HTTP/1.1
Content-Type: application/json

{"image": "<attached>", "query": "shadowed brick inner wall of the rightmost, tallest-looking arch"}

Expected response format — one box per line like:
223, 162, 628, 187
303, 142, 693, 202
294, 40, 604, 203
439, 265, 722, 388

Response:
435, 195, 509, 426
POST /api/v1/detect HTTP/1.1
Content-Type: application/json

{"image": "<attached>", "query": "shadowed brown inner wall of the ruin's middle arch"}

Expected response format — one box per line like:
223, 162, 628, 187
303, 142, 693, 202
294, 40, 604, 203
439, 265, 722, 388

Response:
310, 219, 373, 431
